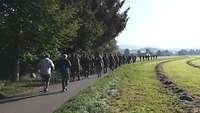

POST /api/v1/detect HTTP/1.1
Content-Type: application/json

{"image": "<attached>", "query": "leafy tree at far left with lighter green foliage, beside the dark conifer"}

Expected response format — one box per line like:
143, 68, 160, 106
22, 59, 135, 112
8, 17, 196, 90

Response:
0, 0, 79, 78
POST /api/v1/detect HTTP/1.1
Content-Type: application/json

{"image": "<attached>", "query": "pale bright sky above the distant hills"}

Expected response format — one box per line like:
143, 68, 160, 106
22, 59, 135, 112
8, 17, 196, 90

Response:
116, 0, 200, 49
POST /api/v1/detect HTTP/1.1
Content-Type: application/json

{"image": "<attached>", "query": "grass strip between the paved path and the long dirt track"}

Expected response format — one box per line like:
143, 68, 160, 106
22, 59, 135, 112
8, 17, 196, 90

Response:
55, 58, 184, 113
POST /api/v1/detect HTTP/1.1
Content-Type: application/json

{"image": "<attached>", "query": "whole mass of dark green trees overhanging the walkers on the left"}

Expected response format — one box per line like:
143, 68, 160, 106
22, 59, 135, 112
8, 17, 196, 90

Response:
0, 0, 129, 79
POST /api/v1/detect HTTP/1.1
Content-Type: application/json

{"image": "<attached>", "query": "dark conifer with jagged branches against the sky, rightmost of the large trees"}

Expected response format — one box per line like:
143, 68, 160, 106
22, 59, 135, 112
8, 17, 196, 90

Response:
73, 0, 129, 51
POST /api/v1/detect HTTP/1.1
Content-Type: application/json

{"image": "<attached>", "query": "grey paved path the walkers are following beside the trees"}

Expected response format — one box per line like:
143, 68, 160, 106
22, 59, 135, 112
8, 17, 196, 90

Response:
0, 75, 104, 113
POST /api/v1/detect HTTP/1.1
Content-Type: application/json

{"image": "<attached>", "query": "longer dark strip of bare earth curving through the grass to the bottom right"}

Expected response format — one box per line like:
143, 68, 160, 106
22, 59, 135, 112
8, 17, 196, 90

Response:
155, 60, 200, 113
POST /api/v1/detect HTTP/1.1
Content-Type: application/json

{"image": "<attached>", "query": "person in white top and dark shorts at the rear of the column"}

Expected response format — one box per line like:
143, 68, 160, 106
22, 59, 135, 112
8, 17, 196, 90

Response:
39, 54, 55, 92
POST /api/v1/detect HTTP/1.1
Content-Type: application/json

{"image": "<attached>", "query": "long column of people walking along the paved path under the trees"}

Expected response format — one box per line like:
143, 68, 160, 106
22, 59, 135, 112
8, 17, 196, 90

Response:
39, 53, 155, 92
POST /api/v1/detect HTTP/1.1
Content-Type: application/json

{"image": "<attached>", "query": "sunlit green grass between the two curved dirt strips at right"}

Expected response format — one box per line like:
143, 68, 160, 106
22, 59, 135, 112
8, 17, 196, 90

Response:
164, 58, 200, 96
